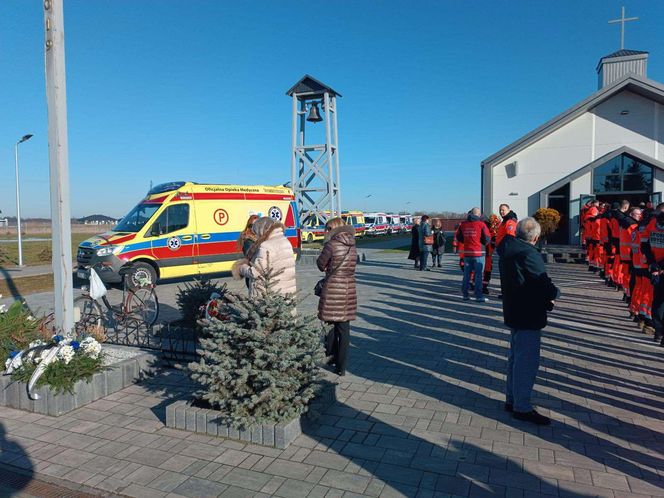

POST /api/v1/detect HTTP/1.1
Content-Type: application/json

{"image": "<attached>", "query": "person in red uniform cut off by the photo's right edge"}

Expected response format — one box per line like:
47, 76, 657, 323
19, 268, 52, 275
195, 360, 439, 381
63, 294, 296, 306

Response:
641, 203, 664, 346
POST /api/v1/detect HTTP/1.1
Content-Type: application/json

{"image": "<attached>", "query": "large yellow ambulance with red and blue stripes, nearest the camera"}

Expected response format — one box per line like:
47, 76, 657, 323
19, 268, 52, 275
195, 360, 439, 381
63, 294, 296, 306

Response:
76, 182, 300, 286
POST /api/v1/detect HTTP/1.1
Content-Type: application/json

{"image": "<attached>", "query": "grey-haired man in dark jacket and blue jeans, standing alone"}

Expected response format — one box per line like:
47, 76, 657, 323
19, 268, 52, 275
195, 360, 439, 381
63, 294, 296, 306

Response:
498, 218, 559, 425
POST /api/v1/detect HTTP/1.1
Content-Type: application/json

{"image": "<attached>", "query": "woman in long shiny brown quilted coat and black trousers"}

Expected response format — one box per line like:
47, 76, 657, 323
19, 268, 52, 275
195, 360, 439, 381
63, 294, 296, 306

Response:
316, 218, 357, 375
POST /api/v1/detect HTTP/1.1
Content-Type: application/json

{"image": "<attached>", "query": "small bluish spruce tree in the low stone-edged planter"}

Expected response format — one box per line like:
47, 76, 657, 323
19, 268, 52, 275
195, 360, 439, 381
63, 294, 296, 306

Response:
189, 259, 325, 428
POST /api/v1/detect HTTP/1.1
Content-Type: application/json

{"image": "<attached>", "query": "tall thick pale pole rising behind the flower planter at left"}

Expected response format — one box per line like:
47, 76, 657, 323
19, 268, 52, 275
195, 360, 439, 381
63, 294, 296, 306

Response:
43, 0, 74, 333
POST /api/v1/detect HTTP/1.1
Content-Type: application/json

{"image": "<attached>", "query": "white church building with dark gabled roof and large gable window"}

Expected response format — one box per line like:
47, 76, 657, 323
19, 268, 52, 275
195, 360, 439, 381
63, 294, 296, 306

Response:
481, 50, 664, 244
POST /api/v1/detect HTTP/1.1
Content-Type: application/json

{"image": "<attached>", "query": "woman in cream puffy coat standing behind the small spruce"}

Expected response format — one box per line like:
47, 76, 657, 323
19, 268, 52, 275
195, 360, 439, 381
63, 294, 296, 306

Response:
234, 217, 297, 296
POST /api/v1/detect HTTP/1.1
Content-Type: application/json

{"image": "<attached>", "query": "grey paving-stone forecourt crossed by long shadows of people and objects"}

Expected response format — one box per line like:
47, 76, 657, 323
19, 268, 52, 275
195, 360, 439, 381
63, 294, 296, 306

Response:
0, 251, 664, 498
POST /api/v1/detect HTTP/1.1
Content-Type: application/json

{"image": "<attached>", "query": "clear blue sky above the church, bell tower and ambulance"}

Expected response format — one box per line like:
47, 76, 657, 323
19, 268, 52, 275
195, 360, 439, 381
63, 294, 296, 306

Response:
0, 0, 664, 216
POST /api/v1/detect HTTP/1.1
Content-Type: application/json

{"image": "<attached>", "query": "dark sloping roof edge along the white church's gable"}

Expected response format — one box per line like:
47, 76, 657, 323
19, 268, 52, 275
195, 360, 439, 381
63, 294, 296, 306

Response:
482, 74, 664, 165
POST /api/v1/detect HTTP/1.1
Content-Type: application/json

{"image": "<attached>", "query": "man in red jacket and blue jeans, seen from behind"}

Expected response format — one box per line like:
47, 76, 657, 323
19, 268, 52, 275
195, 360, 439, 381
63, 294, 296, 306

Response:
456, 208, 491, 303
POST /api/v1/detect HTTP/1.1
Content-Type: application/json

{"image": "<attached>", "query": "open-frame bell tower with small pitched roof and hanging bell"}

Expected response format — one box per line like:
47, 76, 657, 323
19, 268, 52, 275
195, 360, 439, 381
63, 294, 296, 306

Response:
286, 75, 341, 221
